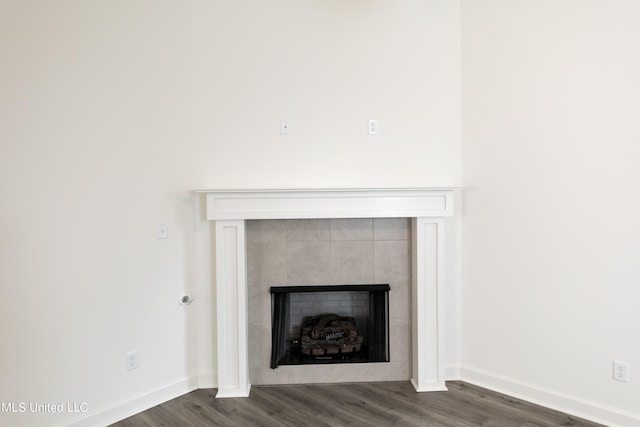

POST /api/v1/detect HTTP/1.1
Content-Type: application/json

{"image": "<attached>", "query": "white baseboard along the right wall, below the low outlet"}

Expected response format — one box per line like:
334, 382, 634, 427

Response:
460, 367, 640, 427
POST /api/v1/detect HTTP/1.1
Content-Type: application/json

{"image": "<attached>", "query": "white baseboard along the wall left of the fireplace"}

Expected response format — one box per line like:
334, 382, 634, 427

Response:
59, 374, 216, 427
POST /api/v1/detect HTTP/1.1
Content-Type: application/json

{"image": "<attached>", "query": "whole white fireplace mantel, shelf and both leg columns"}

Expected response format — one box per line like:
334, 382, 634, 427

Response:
199, 188, 454, 397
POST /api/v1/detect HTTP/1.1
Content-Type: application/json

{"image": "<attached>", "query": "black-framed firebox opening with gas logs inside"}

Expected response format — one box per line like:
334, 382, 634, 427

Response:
271, 284, 390, 369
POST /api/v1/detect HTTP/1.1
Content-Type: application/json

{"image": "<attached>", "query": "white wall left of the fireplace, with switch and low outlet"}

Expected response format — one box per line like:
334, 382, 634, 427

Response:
0, 1, 208, 426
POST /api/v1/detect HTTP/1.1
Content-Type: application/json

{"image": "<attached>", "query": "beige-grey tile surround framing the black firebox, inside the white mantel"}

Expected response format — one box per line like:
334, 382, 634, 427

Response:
247, 218, 411, 385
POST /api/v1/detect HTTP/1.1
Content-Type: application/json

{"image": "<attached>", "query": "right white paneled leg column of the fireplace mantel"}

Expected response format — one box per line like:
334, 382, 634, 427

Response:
411, 218, 447, 391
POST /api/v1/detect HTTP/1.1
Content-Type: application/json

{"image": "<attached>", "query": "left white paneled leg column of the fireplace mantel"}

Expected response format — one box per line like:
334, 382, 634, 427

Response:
215, 220, 251, 397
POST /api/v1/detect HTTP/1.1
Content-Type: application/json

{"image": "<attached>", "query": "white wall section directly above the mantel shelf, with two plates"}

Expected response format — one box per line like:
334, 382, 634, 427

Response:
194, 0, 460, 188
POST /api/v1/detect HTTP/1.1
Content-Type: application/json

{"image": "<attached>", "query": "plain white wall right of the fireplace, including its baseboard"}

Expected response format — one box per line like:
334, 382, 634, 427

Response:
462, 0, 640, 426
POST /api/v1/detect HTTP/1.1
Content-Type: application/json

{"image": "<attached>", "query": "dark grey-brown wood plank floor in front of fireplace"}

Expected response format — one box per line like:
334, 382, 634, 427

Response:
113, 381, 600, 427
